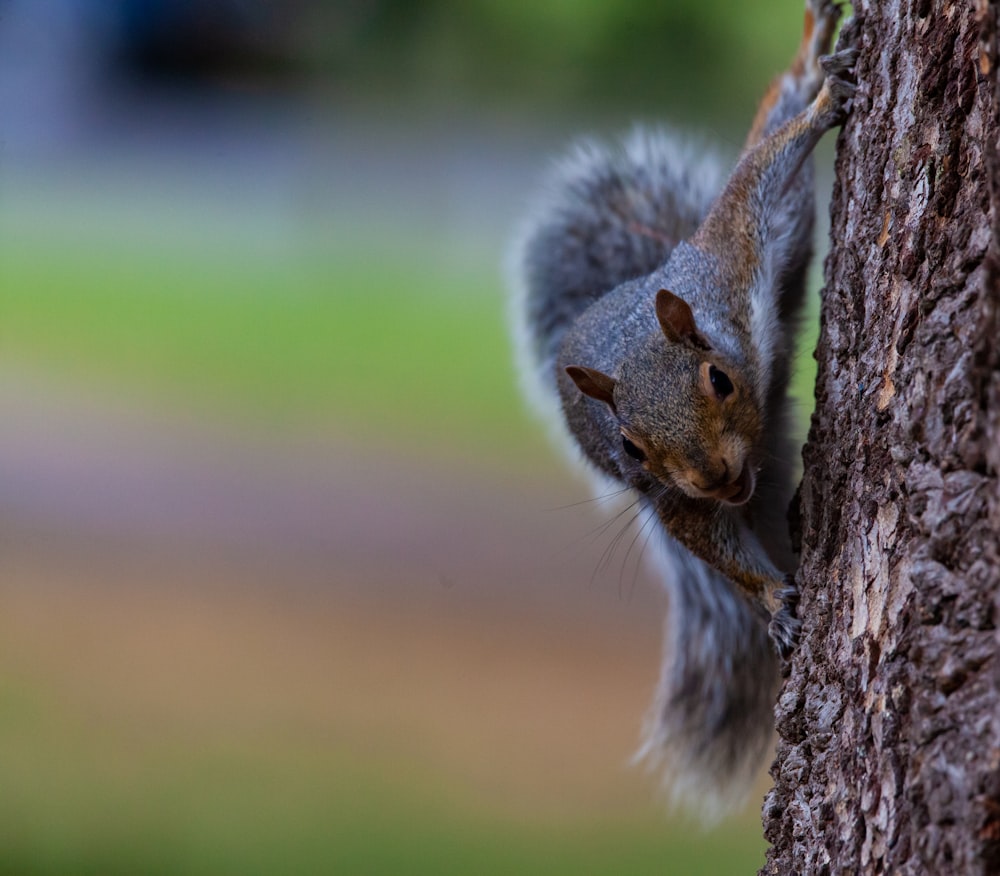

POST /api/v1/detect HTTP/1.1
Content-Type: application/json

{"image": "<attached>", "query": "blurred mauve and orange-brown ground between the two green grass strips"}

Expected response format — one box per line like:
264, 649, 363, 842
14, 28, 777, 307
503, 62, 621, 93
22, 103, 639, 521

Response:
0, 375, 680, 819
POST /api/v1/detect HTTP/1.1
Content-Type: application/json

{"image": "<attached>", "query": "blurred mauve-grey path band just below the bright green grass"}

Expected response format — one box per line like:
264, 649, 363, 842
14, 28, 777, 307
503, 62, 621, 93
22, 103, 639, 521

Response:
0, 376, 672, 627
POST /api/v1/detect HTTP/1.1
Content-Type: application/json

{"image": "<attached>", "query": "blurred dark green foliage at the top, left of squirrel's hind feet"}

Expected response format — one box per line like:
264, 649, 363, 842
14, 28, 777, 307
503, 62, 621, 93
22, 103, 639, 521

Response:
324, 0, 800, 115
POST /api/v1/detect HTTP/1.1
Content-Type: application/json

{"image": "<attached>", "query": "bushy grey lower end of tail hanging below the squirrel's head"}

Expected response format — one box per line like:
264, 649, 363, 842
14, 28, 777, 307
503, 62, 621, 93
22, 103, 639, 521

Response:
635, 539, 780, 821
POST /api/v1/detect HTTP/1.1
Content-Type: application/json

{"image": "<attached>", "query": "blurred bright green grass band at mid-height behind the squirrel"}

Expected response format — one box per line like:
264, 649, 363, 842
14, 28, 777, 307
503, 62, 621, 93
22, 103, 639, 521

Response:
0, 231, 815, 459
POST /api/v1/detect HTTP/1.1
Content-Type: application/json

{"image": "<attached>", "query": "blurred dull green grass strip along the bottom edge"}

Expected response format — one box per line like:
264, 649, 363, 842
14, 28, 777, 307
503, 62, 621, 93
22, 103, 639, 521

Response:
0, 678, 763, 876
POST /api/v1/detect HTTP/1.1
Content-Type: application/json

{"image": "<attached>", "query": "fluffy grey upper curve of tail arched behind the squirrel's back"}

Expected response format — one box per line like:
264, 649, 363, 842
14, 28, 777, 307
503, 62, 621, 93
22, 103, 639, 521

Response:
508, 127, 723, 384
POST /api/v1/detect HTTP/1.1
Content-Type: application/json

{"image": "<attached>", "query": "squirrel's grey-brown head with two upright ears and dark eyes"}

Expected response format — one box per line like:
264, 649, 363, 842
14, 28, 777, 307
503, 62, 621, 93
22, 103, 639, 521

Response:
566, 289, 762, 505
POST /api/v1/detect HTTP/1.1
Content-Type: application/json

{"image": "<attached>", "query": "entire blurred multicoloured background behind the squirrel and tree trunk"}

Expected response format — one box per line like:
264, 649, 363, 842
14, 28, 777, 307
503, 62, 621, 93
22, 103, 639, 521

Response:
0, 0, 830, 874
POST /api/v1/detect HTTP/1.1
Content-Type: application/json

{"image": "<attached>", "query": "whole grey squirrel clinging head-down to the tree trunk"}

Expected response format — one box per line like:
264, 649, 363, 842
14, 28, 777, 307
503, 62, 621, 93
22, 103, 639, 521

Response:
512, 0, 856, 817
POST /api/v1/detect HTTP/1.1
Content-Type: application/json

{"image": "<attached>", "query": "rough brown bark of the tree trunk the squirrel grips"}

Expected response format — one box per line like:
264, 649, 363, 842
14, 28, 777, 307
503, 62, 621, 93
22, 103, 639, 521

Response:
762, 0, 1000, 876
